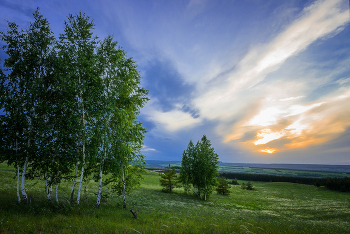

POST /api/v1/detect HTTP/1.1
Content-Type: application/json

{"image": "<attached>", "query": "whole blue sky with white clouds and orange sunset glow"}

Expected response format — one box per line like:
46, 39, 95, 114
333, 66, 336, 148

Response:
0, 0, 350, 165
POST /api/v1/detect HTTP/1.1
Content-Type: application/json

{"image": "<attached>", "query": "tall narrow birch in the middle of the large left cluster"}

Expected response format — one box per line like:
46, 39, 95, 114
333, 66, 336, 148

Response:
59, 12, 101, 204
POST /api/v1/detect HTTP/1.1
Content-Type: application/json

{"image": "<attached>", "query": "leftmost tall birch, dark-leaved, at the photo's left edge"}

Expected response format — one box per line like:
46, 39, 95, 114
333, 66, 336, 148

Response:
1, 9, 53, 202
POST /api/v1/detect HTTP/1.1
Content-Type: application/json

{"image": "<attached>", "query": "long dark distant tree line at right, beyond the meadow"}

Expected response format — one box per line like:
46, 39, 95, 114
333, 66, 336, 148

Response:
220, 172, 350, 192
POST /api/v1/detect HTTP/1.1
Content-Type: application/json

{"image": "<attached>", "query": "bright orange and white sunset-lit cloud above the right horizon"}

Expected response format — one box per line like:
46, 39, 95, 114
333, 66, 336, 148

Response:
225, 91, 350, 157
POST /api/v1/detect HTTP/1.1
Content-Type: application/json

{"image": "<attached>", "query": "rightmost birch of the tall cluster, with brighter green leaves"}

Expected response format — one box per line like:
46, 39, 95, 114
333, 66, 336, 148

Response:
96, 36, 148, 208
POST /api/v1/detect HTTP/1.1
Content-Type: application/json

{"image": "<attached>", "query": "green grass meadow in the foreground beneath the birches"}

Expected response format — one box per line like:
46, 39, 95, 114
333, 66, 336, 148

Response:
0, 164, 350, 234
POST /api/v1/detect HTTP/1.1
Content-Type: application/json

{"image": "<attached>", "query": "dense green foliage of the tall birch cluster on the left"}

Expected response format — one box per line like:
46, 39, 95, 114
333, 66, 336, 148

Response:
0, 9, 149, 206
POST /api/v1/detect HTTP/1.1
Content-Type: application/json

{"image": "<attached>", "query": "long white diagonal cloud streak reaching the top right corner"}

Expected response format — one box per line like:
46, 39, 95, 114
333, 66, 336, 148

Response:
194, 0, 349, 120
